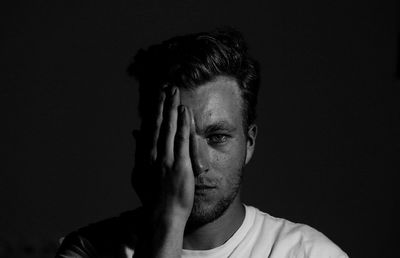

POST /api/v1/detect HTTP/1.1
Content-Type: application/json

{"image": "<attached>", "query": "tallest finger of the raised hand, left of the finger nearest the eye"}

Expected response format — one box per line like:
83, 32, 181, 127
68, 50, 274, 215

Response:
157, 87, 180, 166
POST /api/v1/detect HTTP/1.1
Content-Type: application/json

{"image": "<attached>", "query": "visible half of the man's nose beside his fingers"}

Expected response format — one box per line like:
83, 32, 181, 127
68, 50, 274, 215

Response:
189, 135, 210, 177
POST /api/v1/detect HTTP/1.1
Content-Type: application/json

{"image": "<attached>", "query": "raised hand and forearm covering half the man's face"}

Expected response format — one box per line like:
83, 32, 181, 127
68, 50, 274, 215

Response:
134, 87, 194, 258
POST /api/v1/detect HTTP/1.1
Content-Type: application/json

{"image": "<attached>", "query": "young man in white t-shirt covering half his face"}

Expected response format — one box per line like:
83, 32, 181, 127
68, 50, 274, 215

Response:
57, 29, 347, 258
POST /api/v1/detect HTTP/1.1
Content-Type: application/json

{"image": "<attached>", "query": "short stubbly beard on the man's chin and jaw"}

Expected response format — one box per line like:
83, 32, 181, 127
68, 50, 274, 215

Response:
186, 169, 243, 229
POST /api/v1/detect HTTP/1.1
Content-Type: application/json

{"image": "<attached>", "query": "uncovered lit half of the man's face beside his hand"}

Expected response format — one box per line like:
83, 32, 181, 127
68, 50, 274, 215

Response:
180, 76, 254, 225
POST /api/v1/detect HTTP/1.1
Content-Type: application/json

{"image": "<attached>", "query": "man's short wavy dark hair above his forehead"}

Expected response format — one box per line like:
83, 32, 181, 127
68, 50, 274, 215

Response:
127, 28, 260, 127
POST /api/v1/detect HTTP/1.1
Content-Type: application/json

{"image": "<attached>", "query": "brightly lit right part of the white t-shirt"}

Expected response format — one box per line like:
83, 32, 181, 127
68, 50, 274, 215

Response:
178, 205, 348, 258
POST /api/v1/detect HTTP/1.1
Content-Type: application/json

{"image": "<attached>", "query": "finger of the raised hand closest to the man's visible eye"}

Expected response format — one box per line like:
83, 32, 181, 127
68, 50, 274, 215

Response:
174, 105, 190, 164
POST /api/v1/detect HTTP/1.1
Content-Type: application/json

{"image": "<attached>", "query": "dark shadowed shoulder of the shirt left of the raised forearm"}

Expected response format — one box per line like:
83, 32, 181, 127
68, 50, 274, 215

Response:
57, 208, 142, 257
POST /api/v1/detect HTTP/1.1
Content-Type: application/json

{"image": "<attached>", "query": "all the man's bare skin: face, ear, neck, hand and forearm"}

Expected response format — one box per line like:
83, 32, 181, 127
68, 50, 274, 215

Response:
133, 76, 257, 257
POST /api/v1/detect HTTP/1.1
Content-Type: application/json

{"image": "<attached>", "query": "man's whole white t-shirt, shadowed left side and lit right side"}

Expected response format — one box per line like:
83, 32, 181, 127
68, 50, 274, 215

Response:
56, 205, 348, 258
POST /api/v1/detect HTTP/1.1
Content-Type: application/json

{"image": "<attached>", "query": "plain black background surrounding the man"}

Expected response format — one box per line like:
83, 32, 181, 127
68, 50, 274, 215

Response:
0, 0, 400, 257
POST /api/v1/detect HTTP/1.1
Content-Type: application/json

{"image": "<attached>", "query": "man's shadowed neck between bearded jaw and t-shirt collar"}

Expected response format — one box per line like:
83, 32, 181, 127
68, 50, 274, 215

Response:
183, 193, 245, 250
